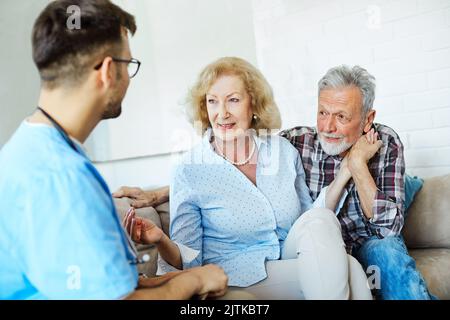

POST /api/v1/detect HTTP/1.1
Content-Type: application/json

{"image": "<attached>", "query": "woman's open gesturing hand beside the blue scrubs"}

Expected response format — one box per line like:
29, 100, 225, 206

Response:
122, 208, 164, 244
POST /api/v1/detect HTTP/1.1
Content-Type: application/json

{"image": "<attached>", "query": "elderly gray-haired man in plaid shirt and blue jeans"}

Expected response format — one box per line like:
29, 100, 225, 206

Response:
281, 66, 431, 299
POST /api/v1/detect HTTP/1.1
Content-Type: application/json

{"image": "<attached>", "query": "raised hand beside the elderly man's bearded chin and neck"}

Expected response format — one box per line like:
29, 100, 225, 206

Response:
347, 129, 383, 171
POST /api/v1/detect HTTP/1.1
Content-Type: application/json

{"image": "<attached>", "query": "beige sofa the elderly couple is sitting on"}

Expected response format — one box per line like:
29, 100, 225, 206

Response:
114, 174, 450, 299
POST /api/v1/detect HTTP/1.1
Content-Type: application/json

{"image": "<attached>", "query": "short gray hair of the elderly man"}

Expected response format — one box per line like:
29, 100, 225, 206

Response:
319, 65, 375, 117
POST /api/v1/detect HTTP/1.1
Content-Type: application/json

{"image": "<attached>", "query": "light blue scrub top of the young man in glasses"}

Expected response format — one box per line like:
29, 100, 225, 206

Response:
0, 121, 138, 299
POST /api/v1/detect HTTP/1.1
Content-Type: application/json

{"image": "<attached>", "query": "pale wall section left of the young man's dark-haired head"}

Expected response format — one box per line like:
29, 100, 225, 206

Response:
0, 0, 48, 148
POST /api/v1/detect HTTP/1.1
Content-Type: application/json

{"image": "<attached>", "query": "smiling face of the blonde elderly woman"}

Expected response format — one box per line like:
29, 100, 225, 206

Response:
206, 75, 253, 141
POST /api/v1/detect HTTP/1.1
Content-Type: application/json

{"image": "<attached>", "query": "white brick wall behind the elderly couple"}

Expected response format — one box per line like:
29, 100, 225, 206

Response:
253, 0, 450, 177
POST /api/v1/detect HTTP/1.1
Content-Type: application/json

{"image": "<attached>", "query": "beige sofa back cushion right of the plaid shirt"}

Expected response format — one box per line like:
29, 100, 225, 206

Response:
403, 174, 450, 248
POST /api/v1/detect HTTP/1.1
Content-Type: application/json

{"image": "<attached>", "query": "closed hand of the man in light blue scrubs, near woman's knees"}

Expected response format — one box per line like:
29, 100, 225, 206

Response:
186, 264, 228, 298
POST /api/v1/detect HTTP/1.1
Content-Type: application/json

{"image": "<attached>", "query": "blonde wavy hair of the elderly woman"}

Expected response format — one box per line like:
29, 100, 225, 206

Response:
187, 57, 281, 134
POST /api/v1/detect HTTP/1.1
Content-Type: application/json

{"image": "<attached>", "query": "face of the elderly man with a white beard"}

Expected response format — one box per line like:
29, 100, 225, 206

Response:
317, 86, 363, 155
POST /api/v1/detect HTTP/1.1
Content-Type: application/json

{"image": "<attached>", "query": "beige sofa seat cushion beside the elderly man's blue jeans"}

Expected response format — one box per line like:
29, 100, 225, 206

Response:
409, 249, 450, 300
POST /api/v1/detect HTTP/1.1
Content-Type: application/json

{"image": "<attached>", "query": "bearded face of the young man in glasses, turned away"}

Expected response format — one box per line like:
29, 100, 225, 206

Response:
102, 32, 131, 119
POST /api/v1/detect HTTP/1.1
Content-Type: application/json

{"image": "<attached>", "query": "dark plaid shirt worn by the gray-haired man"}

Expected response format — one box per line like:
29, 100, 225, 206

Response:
280, 124, 405, 253
